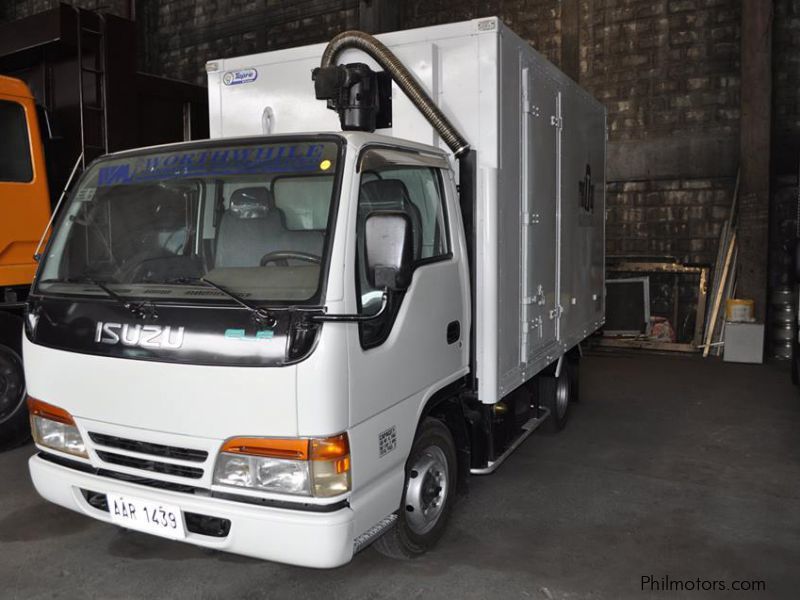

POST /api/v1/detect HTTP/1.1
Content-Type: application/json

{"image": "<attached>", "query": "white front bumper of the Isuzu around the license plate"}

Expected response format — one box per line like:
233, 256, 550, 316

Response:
28, 456, 354, 568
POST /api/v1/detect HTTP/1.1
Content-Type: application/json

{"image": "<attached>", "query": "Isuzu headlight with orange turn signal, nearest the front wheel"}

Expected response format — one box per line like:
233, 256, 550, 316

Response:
214, 433, 350, 498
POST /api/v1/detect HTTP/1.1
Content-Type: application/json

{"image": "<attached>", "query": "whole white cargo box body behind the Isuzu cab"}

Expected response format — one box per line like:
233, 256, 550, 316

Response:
208, 18, 606, 403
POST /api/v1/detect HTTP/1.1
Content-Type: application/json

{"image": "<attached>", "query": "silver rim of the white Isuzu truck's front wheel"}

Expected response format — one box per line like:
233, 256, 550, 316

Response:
405, 446, 450, 535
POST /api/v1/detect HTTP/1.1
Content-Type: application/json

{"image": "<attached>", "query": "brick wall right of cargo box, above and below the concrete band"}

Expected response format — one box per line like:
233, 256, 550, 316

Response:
580, 0, 740, 264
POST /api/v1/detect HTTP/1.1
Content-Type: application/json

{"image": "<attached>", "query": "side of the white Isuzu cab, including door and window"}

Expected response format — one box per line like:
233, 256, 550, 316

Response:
348, 149, 469, 523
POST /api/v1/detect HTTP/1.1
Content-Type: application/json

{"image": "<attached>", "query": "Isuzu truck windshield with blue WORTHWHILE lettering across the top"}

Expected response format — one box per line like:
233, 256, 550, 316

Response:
37, 138, 341, 304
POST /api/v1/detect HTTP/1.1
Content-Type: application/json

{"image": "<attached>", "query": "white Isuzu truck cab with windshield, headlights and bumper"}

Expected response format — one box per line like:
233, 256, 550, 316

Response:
25, 133, 470, 566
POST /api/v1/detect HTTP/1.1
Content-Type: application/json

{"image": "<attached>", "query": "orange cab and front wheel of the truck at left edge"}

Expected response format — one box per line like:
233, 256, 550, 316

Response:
0, 75, 51, 449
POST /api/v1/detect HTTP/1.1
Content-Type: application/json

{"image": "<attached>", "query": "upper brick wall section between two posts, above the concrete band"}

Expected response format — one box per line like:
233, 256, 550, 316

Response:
580, 0, 740, 140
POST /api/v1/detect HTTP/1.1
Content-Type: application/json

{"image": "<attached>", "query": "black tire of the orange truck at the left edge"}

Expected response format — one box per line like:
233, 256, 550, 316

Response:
0, 346, 31, 450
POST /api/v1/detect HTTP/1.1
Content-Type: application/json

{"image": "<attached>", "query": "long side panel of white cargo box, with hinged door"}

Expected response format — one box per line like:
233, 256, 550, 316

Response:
488, 27, 605, 402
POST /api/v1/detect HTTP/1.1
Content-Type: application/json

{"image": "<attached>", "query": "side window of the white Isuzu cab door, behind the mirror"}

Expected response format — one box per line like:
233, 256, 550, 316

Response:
356, 165, 450, 348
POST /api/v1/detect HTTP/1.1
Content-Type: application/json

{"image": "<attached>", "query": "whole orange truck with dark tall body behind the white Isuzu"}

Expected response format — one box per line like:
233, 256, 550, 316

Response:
0, 2, 209, 451
